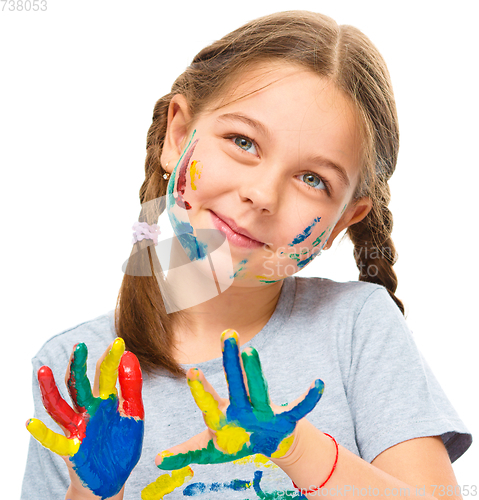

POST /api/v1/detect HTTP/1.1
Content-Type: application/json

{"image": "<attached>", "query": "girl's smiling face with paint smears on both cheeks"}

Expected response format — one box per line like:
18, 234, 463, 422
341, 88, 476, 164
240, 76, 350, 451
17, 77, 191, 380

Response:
162, 64, 370, 286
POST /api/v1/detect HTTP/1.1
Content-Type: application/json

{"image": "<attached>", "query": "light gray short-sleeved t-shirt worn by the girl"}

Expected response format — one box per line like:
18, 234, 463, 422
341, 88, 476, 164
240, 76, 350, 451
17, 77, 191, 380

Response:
21, 277, 472, 500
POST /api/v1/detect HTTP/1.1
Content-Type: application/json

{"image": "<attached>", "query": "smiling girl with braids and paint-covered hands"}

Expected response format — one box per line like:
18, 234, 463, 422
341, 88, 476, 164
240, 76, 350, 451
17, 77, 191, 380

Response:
19, 8, 471, 499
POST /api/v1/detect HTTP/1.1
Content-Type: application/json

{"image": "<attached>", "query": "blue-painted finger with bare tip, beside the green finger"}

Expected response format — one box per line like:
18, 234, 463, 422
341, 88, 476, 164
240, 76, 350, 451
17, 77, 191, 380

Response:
221, 330, 251, 412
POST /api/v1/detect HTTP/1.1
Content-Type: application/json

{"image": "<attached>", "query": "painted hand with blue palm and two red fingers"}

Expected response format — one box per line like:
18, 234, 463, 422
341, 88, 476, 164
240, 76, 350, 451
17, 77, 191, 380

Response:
26, 338, 144, 499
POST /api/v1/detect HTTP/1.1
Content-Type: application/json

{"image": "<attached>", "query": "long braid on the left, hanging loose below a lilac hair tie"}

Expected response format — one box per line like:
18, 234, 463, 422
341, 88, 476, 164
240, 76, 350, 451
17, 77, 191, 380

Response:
115, 90, 184, 377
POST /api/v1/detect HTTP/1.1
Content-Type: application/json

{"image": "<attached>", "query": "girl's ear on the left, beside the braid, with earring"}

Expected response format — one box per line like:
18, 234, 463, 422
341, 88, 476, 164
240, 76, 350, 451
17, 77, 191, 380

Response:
160, 94, 192, 173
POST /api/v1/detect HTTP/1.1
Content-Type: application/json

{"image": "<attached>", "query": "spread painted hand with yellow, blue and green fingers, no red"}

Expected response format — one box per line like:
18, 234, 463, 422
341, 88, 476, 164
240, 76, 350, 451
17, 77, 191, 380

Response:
156, 330, 324, 470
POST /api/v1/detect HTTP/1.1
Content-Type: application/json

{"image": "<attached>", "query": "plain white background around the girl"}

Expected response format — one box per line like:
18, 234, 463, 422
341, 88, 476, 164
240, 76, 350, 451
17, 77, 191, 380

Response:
0, 0, 479, 499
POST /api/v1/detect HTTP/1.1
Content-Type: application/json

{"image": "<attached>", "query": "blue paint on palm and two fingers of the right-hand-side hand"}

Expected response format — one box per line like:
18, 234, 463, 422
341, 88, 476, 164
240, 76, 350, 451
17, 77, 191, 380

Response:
223, 337, 324, 457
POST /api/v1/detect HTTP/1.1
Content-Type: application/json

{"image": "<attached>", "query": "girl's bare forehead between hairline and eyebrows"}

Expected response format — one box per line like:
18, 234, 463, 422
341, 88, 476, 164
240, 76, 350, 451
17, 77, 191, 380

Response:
202, 62, 362, 173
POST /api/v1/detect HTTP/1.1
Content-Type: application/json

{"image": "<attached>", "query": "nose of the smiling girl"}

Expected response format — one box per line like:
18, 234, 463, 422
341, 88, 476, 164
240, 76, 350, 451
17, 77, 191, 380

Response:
239, 165, 284, 214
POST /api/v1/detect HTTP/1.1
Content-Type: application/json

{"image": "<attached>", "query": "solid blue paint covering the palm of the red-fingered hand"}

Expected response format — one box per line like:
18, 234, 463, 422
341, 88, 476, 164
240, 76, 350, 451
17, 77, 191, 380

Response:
71, 396, 144, 498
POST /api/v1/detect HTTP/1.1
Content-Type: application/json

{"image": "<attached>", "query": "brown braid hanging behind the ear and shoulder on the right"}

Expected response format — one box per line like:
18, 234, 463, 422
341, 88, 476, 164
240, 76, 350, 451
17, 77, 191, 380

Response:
347, 182, 404, 314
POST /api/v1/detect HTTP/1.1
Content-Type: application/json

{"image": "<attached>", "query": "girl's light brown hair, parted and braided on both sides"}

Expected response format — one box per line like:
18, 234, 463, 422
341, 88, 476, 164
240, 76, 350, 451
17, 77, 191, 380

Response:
116, 11, 404, 375
